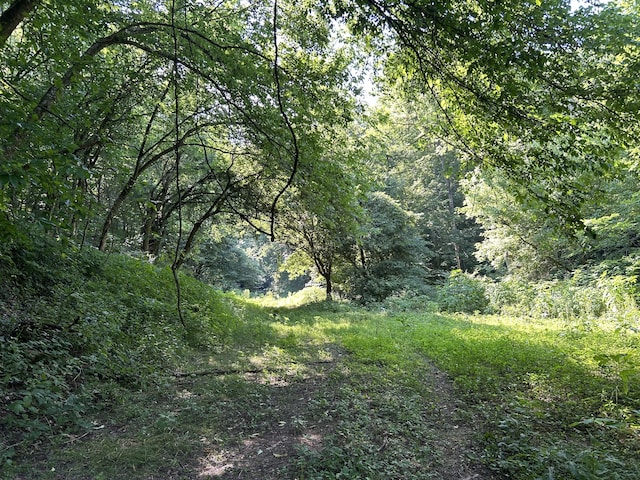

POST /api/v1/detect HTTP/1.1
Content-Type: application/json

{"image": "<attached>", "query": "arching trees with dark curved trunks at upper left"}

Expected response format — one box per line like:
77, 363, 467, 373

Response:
0, 1, 351, 266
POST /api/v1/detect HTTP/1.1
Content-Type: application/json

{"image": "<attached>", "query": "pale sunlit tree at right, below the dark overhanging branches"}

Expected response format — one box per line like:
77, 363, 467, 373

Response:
463, 156, 640, 280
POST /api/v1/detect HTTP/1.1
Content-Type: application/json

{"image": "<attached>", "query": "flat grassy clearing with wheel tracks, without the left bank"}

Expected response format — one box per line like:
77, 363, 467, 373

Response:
8, 307, 640, 480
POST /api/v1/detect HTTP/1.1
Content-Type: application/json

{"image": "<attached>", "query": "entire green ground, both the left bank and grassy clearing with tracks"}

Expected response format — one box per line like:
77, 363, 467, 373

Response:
0, 238, 640, 480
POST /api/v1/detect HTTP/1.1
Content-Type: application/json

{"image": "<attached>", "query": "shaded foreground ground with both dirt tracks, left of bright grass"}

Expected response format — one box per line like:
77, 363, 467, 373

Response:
14, 316, 499, 480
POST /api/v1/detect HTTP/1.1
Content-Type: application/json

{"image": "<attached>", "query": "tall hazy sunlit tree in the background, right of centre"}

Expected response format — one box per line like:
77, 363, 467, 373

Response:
367, 97, 479, 276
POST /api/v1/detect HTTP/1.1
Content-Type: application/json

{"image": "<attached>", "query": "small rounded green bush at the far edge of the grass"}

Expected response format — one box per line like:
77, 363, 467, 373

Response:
438, 270, 489, 313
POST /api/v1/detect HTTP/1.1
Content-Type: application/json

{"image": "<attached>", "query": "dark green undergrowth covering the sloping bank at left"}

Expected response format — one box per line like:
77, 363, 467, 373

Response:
0, 232, 240, 460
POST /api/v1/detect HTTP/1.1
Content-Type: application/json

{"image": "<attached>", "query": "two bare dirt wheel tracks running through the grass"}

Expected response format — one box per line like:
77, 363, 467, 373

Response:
198, 348, 499, 480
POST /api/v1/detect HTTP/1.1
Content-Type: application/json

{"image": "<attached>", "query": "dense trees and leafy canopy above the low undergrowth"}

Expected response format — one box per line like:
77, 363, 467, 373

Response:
0, 1, 638, 301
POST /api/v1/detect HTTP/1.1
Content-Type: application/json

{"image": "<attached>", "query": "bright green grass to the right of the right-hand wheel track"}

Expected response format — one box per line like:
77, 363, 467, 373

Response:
336, 314, 640, 479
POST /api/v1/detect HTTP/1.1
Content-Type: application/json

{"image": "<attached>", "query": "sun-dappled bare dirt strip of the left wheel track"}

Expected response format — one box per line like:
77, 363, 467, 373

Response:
194, 346, 340, 479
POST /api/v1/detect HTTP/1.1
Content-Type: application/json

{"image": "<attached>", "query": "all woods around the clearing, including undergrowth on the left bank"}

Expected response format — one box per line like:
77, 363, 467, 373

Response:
0, 0, 640, 478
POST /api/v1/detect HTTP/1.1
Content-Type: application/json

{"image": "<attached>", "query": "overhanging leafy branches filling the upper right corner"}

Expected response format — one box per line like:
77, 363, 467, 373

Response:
337, 0, 640, 229
